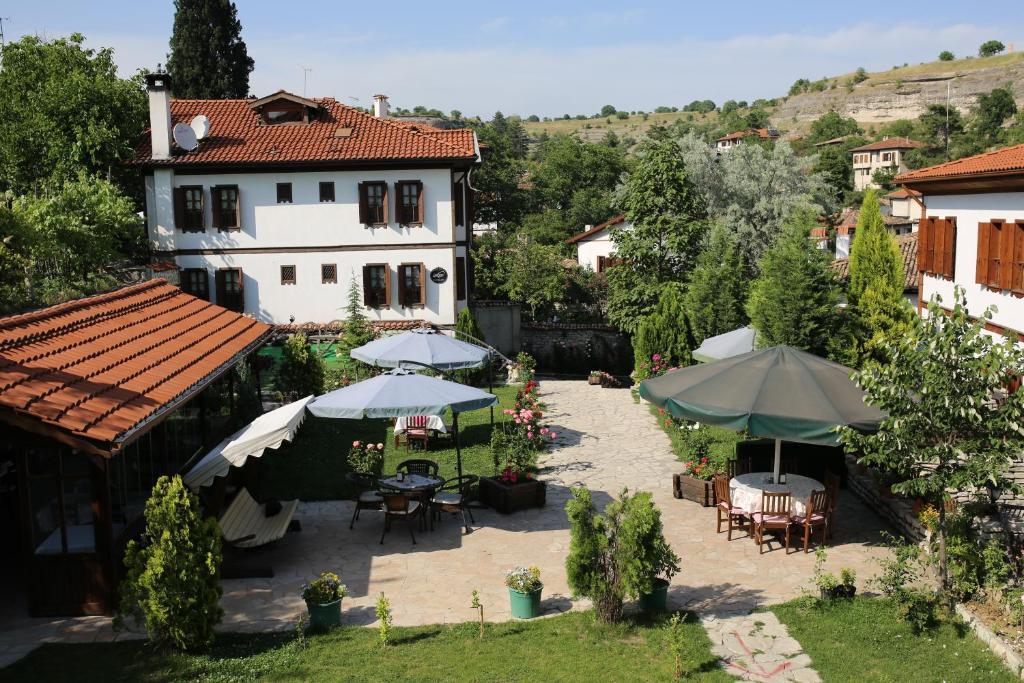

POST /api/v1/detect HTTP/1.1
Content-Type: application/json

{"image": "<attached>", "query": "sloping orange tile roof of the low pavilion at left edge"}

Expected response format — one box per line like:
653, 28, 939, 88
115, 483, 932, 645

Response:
0, 280, 271, 450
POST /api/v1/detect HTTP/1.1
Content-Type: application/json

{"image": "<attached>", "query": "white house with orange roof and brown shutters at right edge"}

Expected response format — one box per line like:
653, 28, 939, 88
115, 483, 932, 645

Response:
896, 144, 1024, 339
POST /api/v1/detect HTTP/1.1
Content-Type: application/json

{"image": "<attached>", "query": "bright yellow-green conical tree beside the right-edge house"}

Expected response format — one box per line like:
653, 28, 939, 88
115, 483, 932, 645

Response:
847, 189, 912, 365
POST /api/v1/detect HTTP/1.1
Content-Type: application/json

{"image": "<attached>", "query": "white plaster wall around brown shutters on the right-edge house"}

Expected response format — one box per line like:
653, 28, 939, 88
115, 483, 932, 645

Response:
922, 193, 1024, 332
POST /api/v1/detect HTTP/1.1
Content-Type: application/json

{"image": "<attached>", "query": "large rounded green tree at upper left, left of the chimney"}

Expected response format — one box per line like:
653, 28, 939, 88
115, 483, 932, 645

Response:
0, 33, 147, 194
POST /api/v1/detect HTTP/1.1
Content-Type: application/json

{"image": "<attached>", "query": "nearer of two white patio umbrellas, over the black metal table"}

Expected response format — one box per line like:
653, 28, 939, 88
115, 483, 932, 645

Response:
308, 368, 498, 476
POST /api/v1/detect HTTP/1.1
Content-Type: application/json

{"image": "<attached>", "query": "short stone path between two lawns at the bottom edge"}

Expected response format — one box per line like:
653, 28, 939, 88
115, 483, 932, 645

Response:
700, 612, 821, 683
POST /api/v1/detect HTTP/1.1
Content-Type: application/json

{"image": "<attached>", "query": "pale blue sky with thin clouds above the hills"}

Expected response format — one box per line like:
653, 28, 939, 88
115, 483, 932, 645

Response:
8, 0, 1024, 116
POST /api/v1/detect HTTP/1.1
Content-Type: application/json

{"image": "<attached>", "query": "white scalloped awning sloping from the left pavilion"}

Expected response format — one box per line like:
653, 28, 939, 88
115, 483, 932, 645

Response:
184, 395, 313, 489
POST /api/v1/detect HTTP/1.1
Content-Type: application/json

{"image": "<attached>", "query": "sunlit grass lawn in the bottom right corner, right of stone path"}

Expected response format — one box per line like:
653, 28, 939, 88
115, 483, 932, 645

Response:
771, 598, 1018, 683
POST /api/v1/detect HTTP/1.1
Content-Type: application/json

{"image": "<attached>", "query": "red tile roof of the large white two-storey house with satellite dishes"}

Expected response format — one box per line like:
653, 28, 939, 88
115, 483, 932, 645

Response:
131, 93, 476, 166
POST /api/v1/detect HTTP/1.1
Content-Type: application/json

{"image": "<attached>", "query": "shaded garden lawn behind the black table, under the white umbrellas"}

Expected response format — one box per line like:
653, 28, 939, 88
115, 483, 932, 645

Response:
252, 385, 519, 501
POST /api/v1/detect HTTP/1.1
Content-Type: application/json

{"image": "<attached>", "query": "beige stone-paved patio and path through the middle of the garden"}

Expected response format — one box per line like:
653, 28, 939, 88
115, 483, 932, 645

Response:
0, 380, 885, 666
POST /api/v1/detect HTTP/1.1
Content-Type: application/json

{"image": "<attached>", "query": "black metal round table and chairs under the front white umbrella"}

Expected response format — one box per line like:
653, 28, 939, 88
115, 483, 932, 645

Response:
347, 459, 479, 544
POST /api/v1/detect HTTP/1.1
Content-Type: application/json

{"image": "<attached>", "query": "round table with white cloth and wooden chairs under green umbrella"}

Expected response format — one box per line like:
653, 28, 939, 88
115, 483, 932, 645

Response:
713, 459, 840, 553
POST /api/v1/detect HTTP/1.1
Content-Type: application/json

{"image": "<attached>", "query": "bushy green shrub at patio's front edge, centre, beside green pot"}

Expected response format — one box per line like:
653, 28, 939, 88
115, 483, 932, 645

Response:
565, 487, 679, 623
